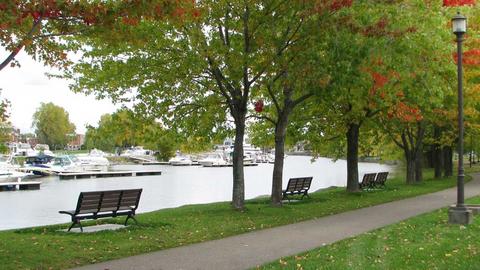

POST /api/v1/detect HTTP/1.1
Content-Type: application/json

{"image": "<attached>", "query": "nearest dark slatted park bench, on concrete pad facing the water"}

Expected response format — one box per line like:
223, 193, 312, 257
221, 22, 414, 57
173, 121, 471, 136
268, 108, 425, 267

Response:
59, 189, 142, 232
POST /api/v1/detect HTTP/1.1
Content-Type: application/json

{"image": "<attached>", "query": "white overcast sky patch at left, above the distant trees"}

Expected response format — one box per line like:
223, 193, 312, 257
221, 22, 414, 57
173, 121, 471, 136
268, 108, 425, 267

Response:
0, 49, 120, 134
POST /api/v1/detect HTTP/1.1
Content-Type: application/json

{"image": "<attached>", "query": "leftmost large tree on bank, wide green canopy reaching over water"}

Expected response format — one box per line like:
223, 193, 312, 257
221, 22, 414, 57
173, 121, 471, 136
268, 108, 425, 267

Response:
63, 0, 318, 209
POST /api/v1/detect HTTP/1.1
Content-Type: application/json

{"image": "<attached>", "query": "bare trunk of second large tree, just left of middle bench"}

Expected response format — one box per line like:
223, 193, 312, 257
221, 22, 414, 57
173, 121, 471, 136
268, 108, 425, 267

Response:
271, 112, 288, 206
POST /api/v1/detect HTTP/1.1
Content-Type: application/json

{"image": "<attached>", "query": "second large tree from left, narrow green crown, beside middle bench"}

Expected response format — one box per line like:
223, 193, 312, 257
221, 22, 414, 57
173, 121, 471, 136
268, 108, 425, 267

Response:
254, 1, 351, 206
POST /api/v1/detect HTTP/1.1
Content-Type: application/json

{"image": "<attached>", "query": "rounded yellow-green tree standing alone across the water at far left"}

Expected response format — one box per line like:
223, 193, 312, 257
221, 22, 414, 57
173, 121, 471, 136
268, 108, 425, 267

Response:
32, 102, 75, 149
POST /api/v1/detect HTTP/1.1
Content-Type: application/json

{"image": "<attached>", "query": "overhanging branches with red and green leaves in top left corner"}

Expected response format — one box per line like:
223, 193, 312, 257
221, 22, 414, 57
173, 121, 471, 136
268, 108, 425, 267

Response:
0, 0, 179, 70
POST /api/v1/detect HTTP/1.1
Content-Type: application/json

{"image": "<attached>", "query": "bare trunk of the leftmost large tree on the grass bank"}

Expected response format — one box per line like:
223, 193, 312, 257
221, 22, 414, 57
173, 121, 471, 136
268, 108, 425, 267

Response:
232, 115, 245, 210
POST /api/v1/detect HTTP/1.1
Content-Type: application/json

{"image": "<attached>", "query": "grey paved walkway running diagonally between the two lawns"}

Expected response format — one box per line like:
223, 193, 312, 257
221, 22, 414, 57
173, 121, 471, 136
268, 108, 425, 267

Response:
78, 174, 480, 270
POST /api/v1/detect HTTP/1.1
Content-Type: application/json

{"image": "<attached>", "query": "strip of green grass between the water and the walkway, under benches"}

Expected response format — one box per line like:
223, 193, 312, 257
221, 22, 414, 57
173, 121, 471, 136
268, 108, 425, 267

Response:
0, 169, 474, 269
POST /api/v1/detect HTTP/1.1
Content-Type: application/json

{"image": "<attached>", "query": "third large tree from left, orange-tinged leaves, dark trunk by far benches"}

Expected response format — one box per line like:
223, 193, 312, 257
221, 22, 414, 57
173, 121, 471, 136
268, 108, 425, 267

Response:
296, 3, 438, 192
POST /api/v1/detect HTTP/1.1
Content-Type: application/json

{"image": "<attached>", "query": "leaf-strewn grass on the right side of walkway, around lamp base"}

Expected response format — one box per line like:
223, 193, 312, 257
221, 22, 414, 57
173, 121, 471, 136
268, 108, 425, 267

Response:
258, 197, 480, 270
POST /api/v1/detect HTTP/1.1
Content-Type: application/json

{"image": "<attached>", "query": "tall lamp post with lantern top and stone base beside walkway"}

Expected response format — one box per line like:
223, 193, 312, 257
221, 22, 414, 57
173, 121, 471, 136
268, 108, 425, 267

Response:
448, 13, 472, 224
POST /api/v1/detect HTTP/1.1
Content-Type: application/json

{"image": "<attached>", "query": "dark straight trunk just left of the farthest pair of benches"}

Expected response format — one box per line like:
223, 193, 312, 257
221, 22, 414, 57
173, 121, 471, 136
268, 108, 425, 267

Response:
347, 124, 360, 192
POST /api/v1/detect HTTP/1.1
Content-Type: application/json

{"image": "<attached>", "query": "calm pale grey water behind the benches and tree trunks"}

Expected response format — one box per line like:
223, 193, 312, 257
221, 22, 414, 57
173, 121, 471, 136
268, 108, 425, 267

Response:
0, 156, 394, 230
